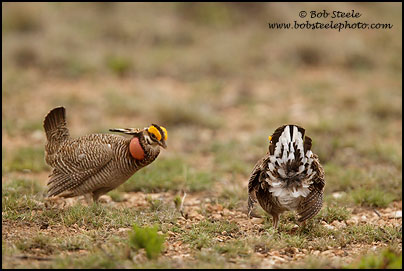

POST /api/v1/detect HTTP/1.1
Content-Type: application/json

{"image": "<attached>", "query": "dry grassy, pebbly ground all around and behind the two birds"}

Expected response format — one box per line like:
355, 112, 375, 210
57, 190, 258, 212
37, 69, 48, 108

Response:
2, 3, 402, 268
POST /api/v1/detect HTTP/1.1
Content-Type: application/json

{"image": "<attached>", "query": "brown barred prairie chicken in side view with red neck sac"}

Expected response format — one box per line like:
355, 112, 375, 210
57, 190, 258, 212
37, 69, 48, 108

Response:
44, 107, 167, 201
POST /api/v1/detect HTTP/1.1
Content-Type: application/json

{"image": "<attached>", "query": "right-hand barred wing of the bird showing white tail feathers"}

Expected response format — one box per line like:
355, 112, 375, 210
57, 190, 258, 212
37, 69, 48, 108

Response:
298, 154, 325, 222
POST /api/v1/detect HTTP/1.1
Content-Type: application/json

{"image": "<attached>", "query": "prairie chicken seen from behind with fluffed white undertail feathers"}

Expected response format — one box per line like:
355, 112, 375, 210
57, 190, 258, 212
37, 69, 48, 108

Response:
248, 125, 325, 228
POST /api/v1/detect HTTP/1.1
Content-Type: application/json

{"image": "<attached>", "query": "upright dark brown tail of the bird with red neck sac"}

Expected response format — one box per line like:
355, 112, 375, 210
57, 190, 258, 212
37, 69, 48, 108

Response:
43, 106, 69, 141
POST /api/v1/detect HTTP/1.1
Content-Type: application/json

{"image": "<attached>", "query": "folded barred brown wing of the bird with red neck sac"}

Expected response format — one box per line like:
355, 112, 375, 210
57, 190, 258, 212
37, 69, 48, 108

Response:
48, 140, 113, 197
